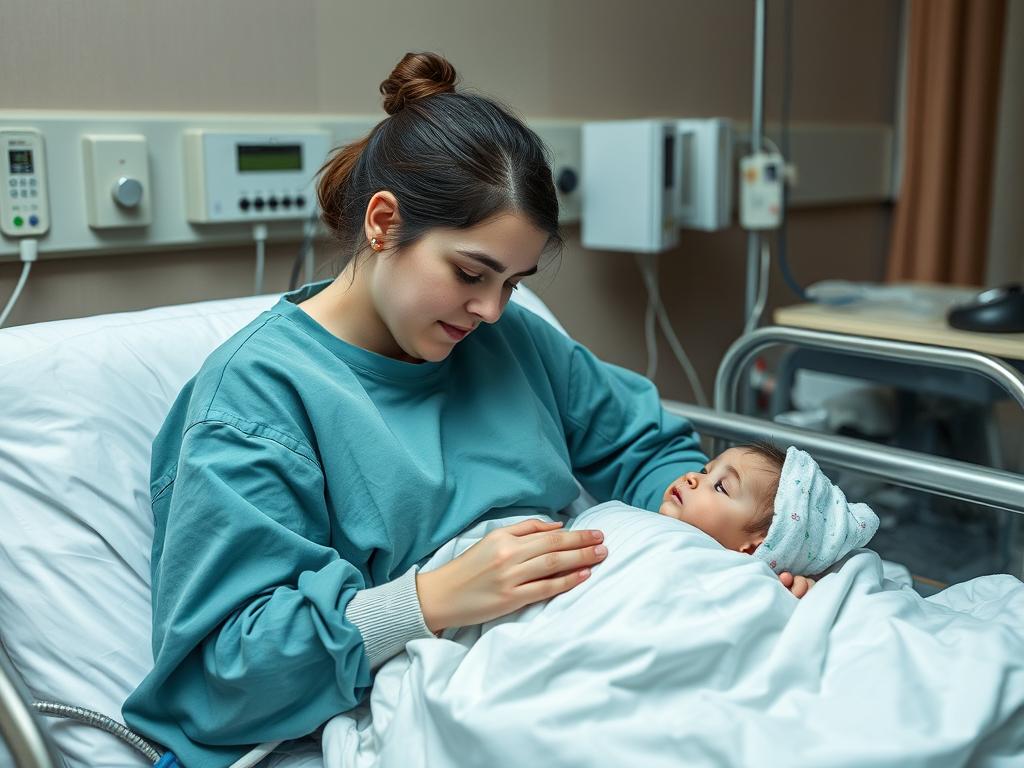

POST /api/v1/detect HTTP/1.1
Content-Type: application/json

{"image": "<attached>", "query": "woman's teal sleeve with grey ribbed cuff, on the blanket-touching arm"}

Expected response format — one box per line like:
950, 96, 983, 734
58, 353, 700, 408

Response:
125, 415, 426, 768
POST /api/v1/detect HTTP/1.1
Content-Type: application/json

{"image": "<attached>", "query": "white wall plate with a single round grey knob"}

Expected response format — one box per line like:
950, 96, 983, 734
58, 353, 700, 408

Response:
82, 134, 153, 229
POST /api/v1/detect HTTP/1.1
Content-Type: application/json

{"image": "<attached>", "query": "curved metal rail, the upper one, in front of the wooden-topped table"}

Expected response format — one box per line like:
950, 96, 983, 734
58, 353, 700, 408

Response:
715, 326, 1024, 413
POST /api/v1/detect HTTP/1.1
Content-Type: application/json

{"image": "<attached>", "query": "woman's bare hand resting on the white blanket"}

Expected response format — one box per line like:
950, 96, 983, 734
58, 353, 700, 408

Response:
416, 520, 608, 632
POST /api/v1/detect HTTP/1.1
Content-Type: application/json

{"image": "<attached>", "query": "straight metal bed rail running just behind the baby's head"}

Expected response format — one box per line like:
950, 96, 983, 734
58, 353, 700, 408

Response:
663, 400, 1024, 514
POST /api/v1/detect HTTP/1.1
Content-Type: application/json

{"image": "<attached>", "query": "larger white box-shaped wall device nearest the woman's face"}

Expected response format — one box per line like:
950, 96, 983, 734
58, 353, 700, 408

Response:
582, 120, 679, 253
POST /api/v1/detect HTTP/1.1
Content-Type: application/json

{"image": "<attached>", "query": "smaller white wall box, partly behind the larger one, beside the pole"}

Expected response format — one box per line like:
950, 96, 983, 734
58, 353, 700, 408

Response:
676, 118, 733, 231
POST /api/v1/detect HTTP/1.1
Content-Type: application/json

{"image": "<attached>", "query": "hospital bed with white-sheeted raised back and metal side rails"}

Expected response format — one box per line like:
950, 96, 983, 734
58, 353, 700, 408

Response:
0, 290, 1024, 768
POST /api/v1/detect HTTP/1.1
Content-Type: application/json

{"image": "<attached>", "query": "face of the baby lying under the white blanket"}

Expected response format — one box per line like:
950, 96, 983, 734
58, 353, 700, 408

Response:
657, 449, 777, 554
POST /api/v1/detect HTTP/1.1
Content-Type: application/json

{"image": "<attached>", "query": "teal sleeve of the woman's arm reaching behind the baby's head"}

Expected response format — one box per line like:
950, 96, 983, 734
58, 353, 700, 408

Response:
564, 344, 708, 510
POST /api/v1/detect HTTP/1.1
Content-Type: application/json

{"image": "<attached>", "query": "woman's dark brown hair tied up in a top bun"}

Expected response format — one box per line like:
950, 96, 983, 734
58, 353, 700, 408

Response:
316, 53, 562, 268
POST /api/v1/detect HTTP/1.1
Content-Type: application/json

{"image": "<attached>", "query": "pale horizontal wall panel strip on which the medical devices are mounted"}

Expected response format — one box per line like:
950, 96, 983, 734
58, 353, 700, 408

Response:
0, 110, 892, 261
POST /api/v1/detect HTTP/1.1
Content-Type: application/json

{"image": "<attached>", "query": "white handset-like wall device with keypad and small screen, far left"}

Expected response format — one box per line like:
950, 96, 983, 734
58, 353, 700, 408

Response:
0, 128, 50, 238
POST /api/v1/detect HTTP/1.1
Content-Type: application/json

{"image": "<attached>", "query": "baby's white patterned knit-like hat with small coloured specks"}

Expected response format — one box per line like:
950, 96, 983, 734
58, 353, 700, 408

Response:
754, 445, 879, 575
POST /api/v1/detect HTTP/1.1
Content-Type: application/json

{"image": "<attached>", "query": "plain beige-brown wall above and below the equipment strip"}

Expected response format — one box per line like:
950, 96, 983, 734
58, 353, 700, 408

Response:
0, 0, 900, 399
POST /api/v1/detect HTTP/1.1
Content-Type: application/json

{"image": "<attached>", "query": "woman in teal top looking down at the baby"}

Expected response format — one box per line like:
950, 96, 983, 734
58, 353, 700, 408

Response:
124, 54, 706, 768
